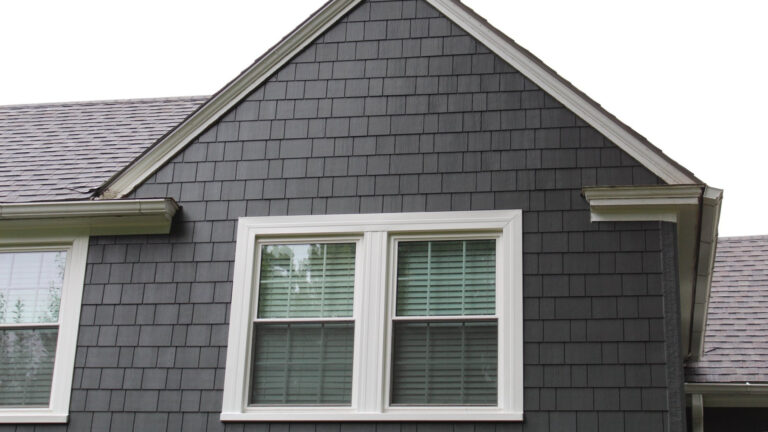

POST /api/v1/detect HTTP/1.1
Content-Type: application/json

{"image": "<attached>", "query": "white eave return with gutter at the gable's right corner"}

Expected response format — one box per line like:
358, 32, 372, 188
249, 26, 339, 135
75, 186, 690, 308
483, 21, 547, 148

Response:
583, 185, 723, 360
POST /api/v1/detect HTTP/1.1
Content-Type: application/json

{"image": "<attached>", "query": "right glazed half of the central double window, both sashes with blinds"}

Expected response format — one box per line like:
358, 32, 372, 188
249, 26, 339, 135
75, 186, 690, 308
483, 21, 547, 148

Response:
390, 239, 498, 405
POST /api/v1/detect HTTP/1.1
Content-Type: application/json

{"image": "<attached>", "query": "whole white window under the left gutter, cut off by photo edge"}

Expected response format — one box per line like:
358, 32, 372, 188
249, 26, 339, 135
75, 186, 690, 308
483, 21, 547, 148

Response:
0, 237, 88, 423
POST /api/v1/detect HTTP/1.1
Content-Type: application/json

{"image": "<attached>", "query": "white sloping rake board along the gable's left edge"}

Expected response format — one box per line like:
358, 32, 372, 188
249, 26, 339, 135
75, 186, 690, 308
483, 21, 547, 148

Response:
100, 0, 361, 199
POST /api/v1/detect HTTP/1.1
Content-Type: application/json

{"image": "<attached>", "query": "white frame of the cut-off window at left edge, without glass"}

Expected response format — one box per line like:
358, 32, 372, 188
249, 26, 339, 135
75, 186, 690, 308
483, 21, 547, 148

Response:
0, 235, 88, 424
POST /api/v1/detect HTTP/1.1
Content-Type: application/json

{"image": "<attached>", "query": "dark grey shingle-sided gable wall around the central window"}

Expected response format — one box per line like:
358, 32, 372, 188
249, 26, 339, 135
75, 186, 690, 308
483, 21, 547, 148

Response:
0, 0, 683, 432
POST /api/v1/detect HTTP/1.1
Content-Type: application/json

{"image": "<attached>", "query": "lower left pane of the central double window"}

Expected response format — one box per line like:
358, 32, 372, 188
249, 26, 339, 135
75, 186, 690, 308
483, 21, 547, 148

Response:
250, 323, 354, 404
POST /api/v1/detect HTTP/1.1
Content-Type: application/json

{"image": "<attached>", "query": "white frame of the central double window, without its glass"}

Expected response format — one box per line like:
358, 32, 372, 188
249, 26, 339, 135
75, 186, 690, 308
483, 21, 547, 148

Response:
221, 210, 523, 421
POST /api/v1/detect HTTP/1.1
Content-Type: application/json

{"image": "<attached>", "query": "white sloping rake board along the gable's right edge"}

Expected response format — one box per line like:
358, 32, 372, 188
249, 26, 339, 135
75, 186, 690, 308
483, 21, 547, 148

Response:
427, 0, 699, 184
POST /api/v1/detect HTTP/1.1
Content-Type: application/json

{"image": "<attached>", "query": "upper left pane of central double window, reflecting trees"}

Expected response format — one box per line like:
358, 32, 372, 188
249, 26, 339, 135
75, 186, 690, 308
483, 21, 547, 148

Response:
258, 243, 355, 318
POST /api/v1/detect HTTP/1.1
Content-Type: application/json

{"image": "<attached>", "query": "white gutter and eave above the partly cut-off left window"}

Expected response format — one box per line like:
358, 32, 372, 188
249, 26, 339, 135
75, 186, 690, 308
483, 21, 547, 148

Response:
0, 198, 179, 238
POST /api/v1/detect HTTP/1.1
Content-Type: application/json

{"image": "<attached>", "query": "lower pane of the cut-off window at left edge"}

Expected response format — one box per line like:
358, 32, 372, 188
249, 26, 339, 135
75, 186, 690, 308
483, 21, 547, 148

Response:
0, 329, 59, 406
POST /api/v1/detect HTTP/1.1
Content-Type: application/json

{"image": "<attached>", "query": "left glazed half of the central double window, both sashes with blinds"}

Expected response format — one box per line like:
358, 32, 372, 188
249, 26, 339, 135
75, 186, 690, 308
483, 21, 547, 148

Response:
255, 243, 356, 405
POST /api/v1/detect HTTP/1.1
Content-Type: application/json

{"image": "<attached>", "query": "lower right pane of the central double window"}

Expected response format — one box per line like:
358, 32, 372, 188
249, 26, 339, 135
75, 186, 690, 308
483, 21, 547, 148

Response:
392, 321, 497, 405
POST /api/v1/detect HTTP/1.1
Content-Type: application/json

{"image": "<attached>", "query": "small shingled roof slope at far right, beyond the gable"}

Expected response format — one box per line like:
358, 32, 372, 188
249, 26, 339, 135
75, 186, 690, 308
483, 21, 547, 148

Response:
686, 235, 768, 383
